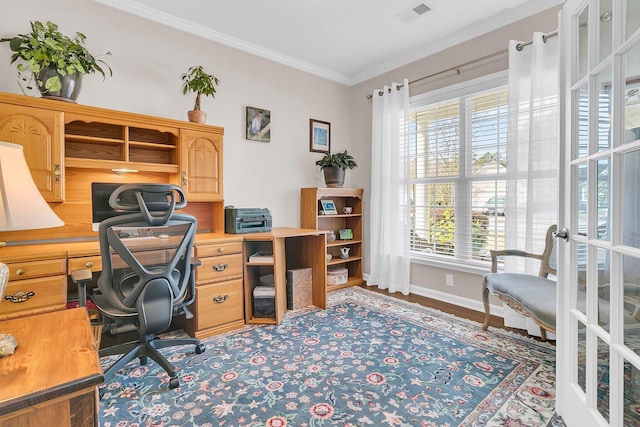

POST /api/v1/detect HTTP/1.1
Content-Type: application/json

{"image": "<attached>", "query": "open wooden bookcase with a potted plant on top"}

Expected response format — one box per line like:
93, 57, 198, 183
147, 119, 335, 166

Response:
300, 187, 364, 291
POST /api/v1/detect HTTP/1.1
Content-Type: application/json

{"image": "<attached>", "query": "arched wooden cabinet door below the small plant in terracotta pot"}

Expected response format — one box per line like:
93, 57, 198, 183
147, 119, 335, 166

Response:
180, 130, 222, 202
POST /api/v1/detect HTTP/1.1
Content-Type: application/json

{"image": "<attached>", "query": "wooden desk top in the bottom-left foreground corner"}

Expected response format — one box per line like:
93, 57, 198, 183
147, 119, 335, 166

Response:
0, 308, 104, 427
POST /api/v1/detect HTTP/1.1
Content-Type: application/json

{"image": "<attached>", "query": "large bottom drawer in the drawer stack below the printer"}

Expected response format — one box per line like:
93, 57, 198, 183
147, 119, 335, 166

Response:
195, 280, 244, 330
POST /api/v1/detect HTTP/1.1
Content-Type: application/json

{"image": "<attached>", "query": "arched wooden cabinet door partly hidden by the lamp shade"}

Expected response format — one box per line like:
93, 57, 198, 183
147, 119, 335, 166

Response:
0, 104, 64, 202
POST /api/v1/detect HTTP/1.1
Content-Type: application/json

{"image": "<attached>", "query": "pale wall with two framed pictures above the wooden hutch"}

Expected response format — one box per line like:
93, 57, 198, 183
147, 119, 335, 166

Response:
0, 0, 356, 227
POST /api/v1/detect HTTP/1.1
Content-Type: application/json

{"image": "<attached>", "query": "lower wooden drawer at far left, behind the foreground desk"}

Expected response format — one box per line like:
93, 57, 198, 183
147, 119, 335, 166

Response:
0, 276, 67, 319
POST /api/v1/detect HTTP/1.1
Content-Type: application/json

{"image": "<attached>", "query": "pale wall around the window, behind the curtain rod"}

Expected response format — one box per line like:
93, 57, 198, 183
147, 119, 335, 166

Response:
350, 7, 560, 309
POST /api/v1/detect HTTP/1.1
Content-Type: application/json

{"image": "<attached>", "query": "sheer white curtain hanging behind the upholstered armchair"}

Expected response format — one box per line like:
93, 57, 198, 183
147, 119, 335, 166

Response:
505, 33, 560, 335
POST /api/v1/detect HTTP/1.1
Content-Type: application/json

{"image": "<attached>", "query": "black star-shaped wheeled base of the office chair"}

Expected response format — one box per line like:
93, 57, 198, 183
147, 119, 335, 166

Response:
99, 338, 205, 389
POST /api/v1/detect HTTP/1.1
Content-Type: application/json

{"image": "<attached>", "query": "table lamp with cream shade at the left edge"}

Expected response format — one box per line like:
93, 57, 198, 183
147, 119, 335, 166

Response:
0, 141, 64, 357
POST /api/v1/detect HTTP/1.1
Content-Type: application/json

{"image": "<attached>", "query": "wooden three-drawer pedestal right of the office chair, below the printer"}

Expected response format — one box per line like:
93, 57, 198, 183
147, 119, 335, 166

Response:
178, 235, 244, 338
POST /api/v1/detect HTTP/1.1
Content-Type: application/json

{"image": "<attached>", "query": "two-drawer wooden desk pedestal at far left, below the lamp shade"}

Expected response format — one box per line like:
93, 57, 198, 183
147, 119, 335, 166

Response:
0, 254, 67, 320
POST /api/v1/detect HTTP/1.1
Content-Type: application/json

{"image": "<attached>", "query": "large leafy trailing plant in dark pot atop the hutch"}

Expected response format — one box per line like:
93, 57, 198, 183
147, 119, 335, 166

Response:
0, 21, 113, 101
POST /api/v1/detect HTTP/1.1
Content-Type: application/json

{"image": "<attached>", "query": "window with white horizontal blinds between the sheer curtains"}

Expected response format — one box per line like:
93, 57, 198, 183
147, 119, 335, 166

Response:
409, 76, 509, 263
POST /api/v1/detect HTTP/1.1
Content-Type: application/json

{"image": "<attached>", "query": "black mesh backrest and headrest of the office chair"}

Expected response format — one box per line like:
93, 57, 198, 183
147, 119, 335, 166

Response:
98, 184, 197, 313
